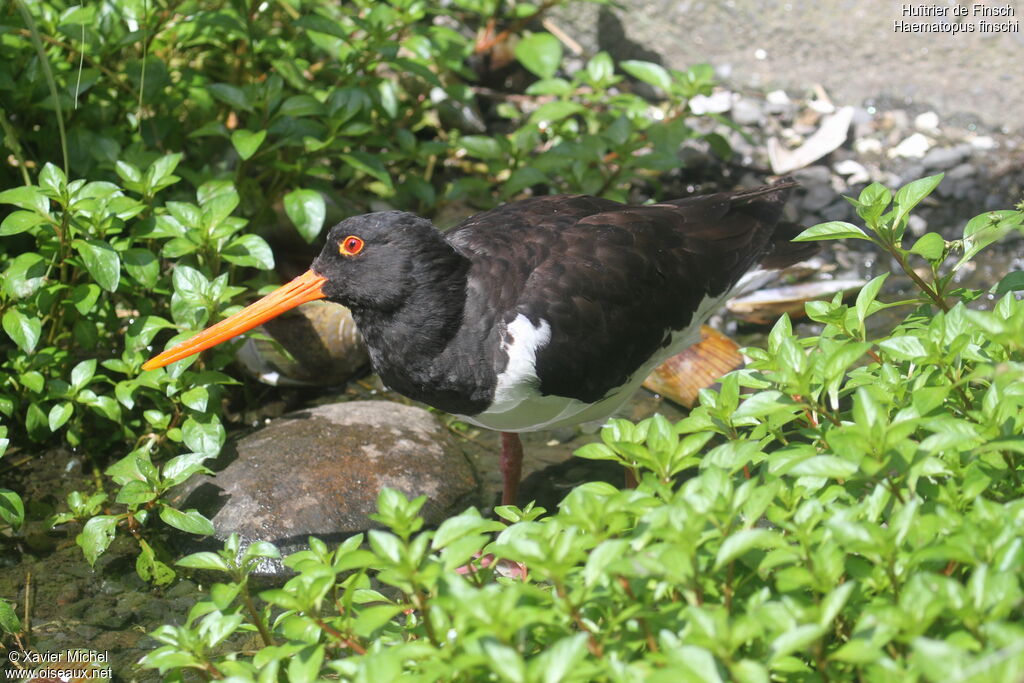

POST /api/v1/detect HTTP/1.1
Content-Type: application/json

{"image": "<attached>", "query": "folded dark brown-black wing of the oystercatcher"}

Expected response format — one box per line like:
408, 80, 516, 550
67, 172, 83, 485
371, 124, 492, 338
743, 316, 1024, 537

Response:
515, 188, 787, 402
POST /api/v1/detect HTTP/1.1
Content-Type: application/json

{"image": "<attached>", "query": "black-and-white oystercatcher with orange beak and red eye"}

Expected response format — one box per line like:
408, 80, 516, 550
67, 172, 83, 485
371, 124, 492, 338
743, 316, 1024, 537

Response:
142, 180, 813, 504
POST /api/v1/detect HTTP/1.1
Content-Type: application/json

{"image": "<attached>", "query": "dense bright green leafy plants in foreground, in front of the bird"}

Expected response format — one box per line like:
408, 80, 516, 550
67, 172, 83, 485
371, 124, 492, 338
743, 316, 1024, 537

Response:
143, 178, 1024, 681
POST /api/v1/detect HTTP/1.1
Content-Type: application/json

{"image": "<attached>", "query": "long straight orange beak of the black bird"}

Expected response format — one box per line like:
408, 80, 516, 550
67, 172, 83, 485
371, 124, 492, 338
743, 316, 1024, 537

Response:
142, 270, 327, 370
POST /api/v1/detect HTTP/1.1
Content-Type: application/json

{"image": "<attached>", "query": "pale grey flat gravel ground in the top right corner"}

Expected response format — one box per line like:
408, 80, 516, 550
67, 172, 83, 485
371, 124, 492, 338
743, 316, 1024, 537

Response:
553, 0, 1024, 132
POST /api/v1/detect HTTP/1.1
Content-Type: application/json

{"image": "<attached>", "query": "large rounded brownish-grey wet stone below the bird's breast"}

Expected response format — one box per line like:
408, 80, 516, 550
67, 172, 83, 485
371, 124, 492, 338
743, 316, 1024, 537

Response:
176, 400, 477, 572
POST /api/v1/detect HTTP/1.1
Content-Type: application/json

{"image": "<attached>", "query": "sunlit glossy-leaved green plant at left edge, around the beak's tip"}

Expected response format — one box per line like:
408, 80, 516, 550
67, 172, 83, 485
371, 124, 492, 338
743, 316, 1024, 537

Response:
0, 155, 273, 581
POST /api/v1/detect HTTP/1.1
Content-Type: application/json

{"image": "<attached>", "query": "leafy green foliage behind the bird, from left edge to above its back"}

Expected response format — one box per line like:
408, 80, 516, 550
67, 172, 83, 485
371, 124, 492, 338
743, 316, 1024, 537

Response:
0, 0, 737, 583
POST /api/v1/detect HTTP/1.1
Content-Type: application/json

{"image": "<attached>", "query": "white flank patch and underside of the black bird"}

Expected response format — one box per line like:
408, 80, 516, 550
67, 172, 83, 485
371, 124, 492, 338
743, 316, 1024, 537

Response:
461, 292, 731, 432
